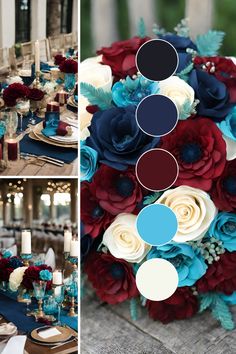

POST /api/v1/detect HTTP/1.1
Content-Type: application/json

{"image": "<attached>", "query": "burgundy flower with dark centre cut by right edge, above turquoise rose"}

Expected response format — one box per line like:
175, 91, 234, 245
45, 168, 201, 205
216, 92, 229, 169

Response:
210, 159, 236, 211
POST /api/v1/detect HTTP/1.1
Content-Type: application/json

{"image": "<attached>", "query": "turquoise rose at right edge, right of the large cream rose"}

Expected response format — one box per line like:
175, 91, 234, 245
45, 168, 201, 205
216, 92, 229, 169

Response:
208, 211, 236, 252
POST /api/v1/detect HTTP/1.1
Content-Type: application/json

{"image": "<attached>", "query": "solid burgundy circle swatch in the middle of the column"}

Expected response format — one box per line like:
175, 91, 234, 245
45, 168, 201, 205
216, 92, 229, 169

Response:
136, 149, 179, 192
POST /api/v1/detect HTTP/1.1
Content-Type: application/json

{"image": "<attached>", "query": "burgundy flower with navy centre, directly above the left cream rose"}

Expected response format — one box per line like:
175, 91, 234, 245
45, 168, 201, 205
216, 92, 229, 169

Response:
91, 165, 143, 215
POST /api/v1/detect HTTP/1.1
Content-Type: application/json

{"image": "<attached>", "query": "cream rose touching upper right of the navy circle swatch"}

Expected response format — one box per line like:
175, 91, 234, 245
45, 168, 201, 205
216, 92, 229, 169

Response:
159, 76, 194, 112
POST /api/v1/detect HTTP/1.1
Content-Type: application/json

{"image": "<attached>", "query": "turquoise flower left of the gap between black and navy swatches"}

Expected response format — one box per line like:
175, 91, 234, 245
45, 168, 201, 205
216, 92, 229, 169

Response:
112, 75, 159, 107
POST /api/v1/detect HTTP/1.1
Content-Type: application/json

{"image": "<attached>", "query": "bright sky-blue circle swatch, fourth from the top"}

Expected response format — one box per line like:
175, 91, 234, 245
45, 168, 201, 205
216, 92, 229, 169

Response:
136, 204, 178, 246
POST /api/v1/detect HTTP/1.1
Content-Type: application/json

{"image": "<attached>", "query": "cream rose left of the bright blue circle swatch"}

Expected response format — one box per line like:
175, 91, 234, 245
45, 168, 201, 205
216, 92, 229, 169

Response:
102, 213, 151, 263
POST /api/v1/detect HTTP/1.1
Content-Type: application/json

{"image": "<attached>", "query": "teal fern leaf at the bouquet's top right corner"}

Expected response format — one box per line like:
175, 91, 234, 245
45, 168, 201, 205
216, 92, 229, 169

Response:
196, 30, 225, 56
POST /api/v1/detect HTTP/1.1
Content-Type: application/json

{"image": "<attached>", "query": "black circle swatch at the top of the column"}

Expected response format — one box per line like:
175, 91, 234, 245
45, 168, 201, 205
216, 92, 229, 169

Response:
136, 39, 179, 81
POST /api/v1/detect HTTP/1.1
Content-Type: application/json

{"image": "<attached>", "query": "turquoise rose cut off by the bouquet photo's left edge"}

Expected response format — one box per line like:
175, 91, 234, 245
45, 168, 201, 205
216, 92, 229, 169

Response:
80, 142, 98, 181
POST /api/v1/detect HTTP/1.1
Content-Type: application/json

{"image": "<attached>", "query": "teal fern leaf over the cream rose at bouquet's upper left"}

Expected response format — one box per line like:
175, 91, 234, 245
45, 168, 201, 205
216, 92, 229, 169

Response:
80, 82, 112, 110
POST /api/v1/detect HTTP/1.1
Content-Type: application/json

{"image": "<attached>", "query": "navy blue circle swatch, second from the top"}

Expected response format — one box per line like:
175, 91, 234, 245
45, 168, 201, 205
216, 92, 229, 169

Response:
136, 95, 178, 136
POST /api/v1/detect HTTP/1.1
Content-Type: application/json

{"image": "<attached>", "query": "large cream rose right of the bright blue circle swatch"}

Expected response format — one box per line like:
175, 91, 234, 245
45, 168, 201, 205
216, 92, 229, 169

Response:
156, 186, 217, 242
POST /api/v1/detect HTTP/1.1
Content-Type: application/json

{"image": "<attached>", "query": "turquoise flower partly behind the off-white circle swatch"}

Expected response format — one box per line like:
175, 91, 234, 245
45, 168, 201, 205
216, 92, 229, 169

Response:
147, 242, 207, 287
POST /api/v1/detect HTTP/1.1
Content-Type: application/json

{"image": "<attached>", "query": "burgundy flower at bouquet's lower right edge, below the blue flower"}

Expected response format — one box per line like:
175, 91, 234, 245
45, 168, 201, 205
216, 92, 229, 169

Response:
196, 252, 236, 295
